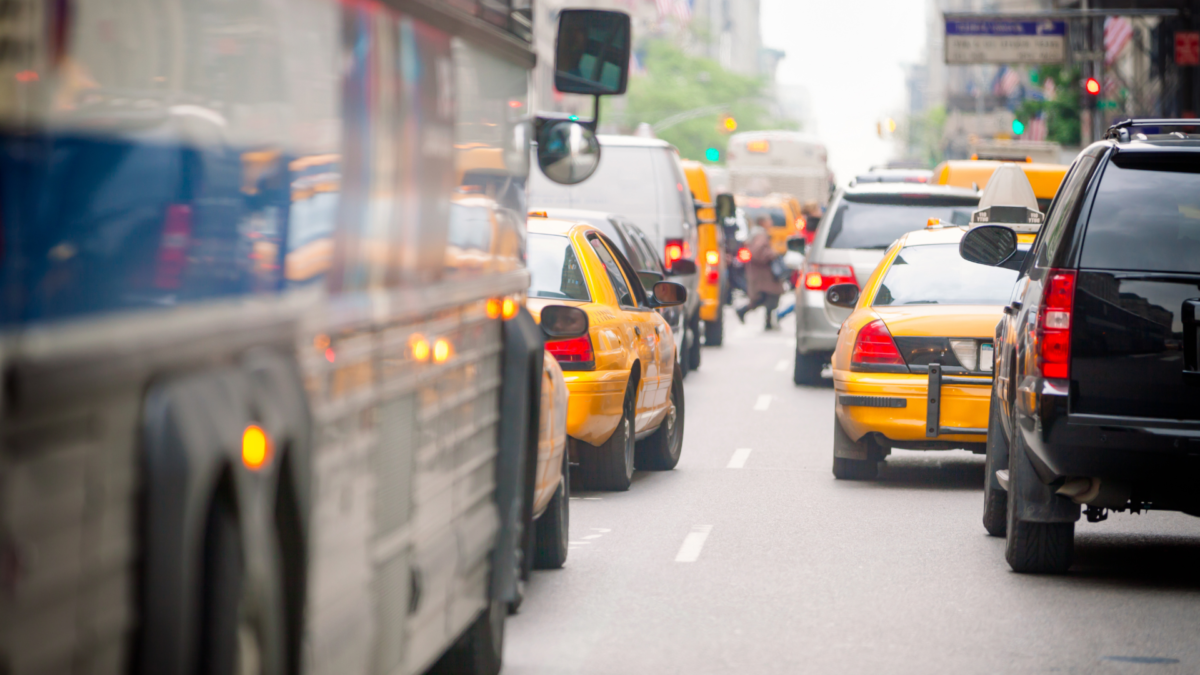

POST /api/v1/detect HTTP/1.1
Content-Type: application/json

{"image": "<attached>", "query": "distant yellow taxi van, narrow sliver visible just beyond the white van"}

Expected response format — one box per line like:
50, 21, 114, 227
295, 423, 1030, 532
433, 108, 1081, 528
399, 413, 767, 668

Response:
682, 160, 728, 347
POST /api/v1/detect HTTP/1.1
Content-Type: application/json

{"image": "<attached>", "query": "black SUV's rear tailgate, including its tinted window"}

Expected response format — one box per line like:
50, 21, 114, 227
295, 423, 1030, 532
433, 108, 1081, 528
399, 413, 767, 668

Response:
1070, 151, 1200, 420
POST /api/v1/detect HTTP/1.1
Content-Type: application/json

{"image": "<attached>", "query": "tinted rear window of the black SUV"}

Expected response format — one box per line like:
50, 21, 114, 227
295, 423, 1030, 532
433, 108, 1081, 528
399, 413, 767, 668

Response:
1080, 154, 1200, 273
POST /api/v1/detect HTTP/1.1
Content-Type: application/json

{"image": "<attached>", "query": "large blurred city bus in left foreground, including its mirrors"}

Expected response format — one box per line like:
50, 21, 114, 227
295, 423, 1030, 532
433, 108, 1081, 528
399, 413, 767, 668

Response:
0, 0, 629, 675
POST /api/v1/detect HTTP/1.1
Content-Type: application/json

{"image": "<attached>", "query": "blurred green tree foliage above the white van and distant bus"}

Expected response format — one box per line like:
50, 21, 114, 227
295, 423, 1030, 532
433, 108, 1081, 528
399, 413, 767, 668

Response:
601, 40, 799, 160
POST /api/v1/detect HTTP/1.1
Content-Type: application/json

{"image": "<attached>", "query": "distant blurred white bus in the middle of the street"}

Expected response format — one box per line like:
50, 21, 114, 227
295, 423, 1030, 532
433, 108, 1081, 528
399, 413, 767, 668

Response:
725, 131, 833, 207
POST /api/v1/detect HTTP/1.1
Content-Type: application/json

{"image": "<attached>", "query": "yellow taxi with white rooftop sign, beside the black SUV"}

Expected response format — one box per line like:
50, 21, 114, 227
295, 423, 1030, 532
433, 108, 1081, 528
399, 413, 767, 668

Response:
826, 164, 1042, 479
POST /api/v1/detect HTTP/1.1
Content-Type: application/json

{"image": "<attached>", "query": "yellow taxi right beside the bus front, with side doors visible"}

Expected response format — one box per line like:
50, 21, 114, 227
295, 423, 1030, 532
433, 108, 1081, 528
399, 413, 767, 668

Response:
526, 217, 688, 490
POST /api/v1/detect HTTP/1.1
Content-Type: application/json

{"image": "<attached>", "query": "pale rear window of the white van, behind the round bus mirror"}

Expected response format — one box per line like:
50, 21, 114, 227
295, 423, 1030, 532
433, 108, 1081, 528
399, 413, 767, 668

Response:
529, 145, 659, 227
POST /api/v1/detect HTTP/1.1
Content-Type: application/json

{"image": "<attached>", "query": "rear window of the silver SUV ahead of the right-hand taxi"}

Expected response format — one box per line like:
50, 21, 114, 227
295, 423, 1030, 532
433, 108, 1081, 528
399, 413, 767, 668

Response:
826, 196, 979, 250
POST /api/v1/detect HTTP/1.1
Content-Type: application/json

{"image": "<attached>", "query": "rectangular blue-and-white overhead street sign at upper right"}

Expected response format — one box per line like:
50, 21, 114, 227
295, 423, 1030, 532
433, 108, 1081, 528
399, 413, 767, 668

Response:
946, 19, 1067, 64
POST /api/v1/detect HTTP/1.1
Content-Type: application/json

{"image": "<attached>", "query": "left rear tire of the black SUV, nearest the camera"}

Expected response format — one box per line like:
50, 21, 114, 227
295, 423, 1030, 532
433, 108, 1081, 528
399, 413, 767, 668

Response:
1004, 434, 1075, 574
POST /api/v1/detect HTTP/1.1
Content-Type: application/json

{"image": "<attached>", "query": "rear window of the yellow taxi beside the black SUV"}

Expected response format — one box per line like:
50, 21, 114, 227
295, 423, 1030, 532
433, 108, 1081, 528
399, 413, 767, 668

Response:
871, 244, 1028, 306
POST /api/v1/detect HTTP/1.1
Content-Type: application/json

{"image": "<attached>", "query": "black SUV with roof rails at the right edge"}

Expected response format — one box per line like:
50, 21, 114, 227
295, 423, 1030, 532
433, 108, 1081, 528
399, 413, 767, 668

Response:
960, 120, 1200, 573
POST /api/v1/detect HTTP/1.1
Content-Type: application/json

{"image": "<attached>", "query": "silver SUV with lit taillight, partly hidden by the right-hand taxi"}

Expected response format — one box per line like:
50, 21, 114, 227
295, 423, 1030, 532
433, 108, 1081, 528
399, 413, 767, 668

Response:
792, 183, 979, 384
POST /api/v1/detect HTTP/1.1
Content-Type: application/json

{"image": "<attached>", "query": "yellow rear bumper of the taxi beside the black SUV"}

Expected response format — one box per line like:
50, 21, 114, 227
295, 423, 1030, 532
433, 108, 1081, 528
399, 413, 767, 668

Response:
833, 369, 991, 449
